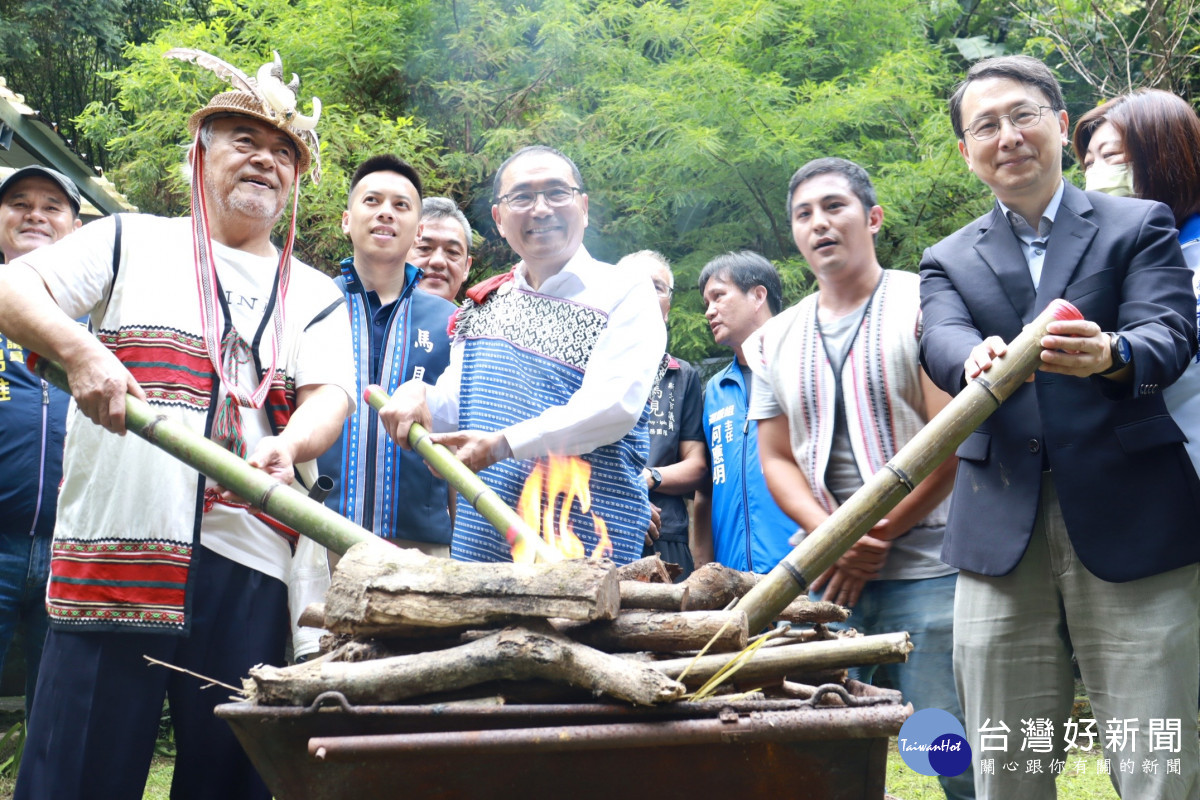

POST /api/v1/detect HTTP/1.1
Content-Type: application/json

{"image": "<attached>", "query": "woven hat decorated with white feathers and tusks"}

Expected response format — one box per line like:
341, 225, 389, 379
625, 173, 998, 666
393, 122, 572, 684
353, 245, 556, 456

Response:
163, 47, 320, 184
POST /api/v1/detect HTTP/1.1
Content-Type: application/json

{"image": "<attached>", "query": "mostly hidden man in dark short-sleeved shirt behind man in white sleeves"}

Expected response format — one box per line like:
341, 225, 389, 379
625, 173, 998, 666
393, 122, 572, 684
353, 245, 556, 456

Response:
617, 249, 708, 582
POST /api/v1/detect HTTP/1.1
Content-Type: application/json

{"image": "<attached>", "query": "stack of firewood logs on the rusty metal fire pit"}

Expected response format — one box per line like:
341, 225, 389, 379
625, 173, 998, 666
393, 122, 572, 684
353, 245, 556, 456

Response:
245, 543, 911, 705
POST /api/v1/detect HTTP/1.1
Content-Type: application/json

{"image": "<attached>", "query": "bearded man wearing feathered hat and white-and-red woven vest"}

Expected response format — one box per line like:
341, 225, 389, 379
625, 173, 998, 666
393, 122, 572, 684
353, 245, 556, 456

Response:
0, 50, 354, 799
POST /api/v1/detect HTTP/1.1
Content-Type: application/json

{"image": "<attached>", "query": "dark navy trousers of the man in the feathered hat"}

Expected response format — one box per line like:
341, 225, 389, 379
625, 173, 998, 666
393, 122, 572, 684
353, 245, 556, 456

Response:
14, 547, 289, 800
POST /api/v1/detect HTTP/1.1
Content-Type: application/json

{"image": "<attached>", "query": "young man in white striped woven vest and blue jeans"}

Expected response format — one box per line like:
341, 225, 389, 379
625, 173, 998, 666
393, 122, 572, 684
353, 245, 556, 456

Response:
746, 158, 974, 800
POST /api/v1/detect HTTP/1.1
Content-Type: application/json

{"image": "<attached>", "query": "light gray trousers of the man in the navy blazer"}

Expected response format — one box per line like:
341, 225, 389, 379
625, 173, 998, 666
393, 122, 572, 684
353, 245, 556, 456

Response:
954, 473, 1200, 800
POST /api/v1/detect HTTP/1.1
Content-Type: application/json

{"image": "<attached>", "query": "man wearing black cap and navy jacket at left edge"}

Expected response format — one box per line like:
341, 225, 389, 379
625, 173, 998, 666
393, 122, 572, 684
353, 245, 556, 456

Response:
0, 166, 82, 712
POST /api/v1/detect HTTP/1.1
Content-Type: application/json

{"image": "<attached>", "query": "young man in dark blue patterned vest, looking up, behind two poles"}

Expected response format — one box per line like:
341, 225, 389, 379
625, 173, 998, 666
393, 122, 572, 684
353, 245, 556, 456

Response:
319, 155, 455, 566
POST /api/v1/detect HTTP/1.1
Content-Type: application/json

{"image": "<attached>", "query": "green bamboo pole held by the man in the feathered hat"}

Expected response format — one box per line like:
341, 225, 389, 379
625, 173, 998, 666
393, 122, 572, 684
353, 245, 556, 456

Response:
28, 353, 383, 555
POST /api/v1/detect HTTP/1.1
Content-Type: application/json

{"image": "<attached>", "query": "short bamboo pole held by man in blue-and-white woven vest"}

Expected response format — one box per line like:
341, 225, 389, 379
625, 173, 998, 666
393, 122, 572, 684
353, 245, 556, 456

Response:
362, 386, 563, 561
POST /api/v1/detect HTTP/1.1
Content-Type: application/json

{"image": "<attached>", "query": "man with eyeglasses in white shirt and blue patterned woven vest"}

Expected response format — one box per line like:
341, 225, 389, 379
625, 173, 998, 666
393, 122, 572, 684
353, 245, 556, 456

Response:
380, 145, 666, 564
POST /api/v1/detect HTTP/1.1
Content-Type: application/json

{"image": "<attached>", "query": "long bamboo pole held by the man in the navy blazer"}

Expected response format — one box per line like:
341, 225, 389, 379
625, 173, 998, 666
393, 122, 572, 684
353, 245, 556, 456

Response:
736, 300, 1082, 631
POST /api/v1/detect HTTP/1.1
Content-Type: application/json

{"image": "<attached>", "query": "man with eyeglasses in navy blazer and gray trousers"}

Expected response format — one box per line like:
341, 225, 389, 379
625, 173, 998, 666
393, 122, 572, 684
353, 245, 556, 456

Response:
920, 56, 1200, 800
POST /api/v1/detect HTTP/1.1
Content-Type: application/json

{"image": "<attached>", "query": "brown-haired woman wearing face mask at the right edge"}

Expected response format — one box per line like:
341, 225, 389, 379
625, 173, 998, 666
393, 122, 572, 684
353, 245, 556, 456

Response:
1072, 89, 1200, 471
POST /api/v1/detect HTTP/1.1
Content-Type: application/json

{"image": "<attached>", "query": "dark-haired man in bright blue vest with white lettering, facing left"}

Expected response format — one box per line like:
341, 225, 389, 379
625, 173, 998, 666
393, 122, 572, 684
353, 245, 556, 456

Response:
691, 251, 796, 573
